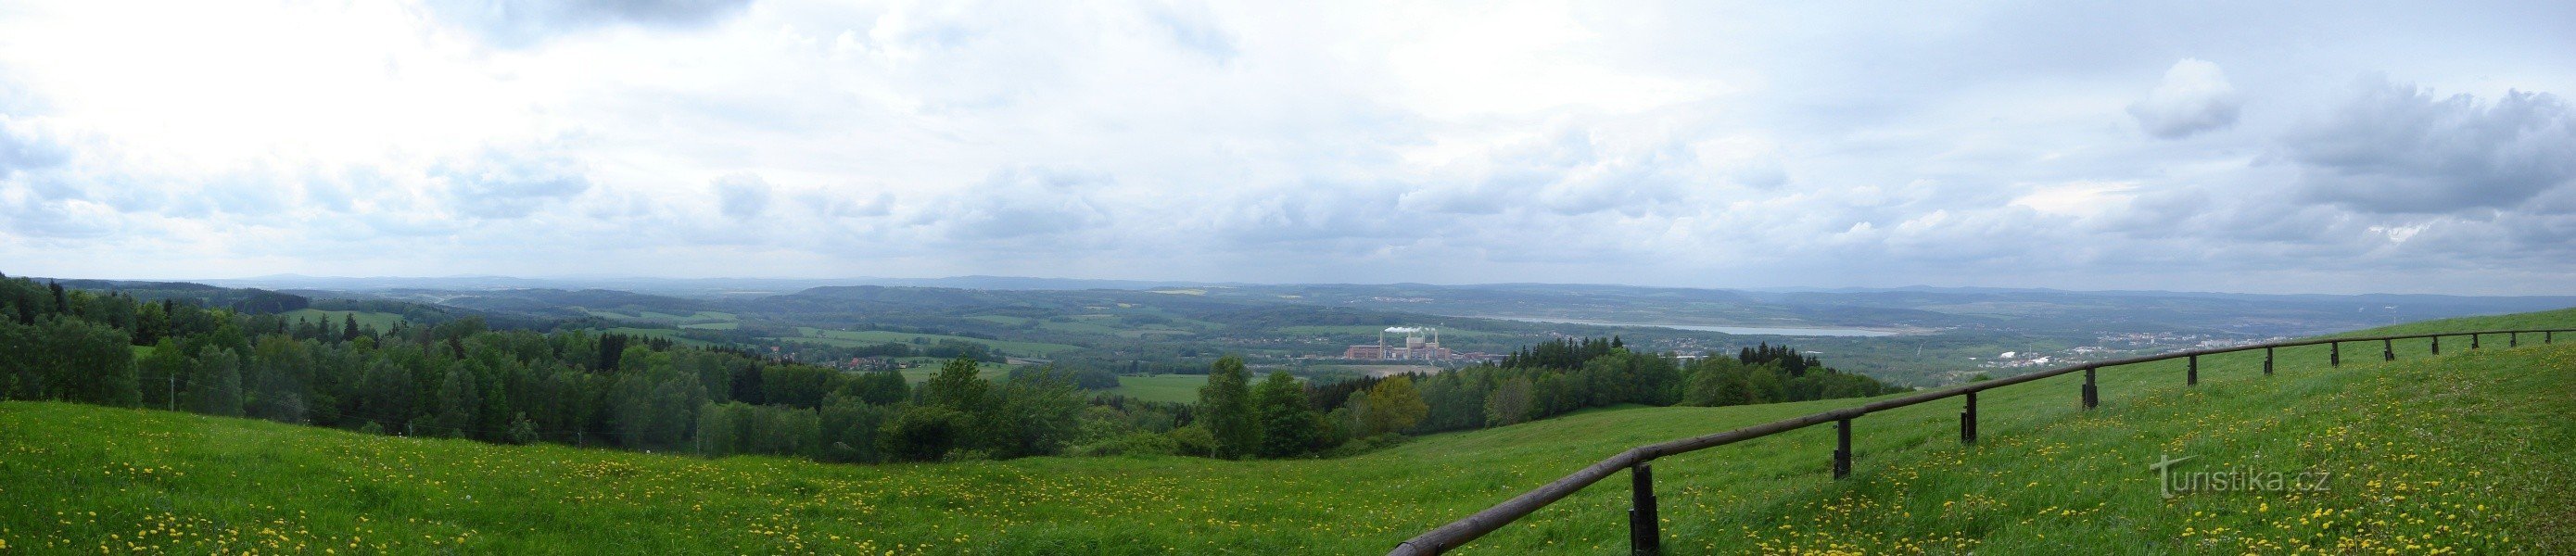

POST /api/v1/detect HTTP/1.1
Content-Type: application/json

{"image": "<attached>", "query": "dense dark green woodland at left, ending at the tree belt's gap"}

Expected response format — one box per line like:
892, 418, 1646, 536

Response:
0, 278, 1148, 461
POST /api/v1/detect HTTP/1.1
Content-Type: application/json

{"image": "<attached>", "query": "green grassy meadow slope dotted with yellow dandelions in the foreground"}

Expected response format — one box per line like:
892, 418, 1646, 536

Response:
0, 311, 2576, 553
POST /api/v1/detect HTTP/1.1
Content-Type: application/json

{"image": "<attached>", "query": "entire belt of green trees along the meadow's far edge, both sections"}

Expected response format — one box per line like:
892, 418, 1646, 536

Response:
0, 275, 1901, 463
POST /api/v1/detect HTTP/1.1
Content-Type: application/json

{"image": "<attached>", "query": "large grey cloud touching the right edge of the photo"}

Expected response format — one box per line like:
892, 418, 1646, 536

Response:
2279, 77, 2576, 214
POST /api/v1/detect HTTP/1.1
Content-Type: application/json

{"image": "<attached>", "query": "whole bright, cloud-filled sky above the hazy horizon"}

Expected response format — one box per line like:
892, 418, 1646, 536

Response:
0, 0, 2576, 294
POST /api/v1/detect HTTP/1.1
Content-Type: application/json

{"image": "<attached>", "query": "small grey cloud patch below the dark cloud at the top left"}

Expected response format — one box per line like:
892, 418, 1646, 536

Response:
430, 149, 590, 219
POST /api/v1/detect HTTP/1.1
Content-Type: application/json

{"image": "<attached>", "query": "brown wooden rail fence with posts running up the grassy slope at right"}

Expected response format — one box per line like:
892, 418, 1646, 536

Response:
1389, 330, 2576, 556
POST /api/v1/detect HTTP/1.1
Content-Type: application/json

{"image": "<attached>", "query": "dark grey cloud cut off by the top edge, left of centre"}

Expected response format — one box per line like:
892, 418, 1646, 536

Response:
430, 0, 752, 49
